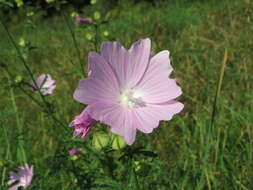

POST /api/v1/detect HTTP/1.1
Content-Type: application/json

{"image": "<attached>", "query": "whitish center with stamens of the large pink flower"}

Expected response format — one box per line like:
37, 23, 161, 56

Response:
118, 89, 145, 109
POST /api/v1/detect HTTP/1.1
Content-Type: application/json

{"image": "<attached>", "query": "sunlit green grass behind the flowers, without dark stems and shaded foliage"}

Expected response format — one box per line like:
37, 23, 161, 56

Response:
0, 0, 253, 190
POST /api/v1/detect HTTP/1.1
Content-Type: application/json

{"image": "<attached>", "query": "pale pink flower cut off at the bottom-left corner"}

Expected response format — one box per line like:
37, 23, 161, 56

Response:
7, 164, 33, 190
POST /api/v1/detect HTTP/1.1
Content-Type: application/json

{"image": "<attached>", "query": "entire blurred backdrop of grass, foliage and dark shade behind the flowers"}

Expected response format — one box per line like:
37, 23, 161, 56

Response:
0, 0, 253, 190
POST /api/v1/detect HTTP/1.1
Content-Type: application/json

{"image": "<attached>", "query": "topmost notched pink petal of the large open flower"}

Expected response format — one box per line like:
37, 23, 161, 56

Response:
101, 39, 151, 89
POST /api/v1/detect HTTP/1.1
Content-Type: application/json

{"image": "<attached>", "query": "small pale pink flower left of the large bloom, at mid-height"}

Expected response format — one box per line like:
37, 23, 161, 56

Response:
30, 74, 56, 95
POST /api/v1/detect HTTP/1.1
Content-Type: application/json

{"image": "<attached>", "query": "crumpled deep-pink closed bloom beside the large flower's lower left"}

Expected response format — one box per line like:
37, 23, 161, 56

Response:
69, 107, 96, 138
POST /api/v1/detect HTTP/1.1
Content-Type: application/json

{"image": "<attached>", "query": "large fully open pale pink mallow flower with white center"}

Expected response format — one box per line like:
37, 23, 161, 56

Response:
74, 39, 184, 145
